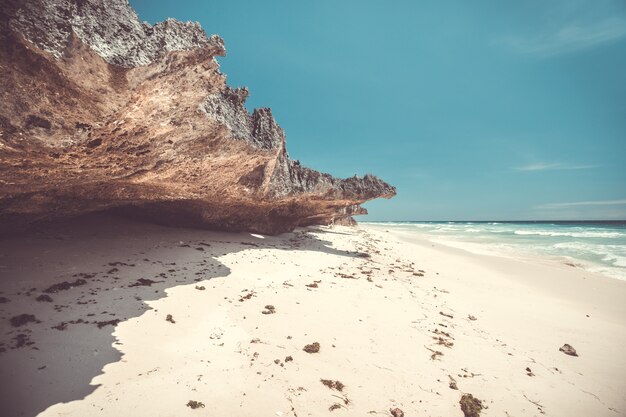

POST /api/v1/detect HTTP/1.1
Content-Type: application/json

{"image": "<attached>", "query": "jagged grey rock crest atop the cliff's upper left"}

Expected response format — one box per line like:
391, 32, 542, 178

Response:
10, 0, 225, 68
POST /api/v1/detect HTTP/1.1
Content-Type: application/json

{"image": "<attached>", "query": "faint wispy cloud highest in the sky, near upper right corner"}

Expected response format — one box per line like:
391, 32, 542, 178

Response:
499, 17, 626, 58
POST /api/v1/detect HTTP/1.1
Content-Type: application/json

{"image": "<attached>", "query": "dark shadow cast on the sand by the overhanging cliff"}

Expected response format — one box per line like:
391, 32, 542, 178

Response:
0, 214, 359, 417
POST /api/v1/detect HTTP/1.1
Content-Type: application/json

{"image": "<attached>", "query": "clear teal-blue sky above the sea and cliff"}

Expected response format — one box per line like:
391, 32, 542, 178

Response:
130, 0, 626, 221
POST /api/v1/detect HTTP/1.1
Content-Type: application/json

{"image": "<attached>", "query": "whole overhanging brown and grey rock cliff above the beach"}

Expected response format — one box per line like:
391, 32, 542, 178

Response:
0, 0, 395, 233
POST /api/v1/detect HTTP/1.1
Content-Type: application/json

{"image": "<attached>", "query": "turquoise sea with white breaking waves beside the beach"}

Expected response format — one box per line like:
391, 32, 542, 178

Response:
368, 221, 626, 280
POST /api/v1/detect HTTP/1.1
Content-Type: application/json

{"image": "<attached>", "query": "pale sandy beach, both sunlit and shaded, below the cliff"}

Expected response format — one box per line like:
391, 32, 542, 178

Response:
0, 216, 626, 417
